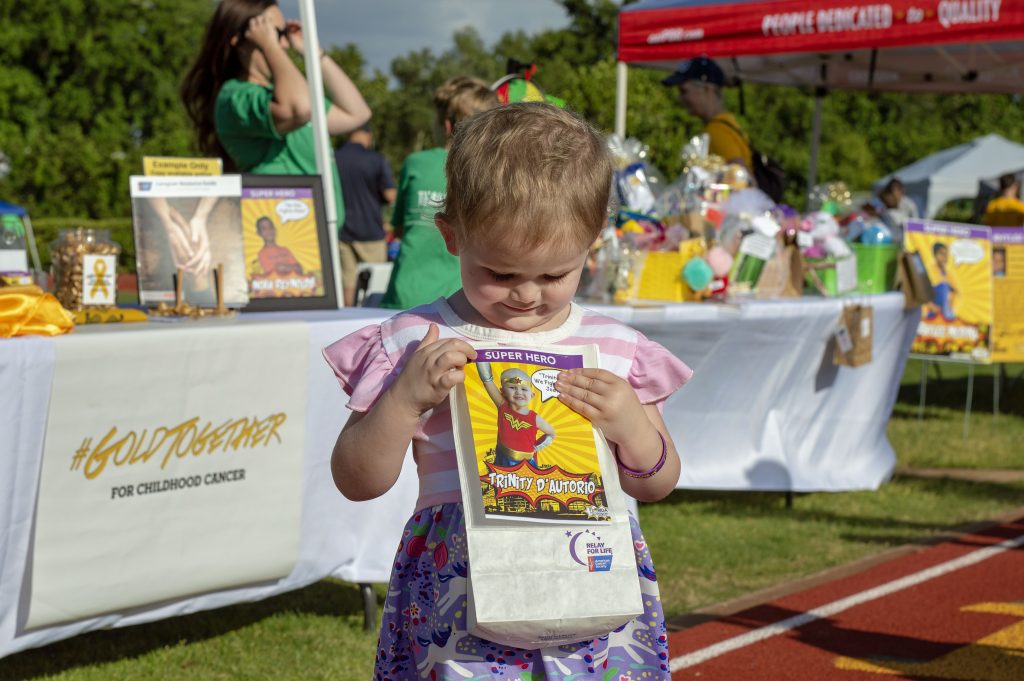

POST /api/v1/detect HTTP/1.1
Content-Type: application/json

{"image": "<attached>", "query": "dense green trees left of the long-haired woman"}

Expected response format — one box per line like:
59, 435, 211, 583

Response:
0, 0, 213, 217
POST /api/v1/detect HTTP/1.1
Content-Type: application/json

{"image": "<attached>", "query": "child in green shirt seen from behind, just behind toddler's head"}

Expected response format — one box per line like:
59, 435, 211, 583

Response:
380, 76, 499, 309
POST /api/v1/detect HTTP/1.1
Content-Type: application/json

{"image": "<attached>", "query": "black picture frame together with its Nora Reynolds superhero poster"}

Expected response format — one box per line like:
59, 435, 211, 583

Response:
242, 175, 338, 311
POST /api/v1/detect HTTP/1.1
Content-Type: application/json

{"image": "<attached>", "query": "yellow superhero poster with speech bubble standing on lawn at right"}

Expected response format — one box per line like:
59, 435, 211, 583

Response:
904, 220, 993, 361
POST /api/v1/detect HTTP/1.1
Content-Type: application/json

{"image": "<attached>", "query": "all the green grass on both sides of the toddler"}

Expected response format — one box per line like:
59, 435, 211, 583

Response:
0, 352, 1024, 681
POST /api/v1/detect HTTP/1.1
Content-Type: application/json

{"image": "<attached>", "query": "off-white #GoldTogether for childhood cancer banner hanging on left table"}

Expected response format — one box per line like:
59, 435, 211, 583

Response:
26, 323, 309, 628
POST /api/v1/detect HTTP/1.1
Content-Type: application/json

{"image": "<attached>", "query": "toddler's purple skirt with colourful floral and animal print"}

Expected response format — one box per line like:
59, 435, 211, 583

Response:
374, 504, 670, 681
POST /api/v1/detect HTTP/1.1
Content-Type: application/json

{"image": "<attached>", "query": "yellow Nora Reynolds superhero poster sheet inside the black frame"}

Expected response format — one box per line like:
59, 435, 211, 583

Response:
242, 187, 324, 298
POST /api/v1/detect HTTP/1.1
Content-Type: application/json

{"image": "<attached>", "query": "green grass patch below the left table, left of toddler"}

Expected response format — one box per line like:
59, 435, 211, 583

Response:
0, 580, 377, 681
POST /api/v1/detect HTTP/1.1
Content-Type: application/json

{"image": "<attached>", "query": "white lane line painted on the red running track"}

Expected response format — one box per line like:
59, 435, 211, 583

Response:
669, 535, 1024, 672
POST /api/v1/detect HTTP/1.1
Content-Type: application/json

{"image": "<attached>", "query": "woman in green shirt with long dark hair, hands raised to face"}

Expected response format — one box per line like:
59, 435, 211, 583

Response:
181, 0, 371, 260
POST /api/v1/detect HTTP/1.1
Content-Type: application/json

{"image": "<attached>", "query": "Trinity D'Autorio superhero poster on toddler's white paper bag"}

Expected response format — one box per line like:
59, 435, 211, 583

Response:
455, 348, 611, 522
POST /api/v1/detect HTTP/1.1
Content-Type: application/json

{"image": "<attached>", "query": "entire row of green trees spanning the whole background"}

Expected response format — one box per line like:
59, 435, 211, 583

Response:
0, 0, 1024, 218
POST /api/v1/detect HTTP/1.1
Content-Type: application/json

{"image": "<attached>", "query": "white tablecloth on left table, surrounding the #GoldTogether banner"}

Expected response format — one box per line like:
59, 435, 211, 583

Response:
0, 308, 418, 657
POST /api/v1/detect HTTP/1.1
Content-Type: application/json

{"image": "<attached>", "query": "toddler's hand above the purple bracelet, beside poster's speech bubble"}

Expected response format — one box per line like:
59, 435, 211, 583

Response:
555, 369, 651, 443
